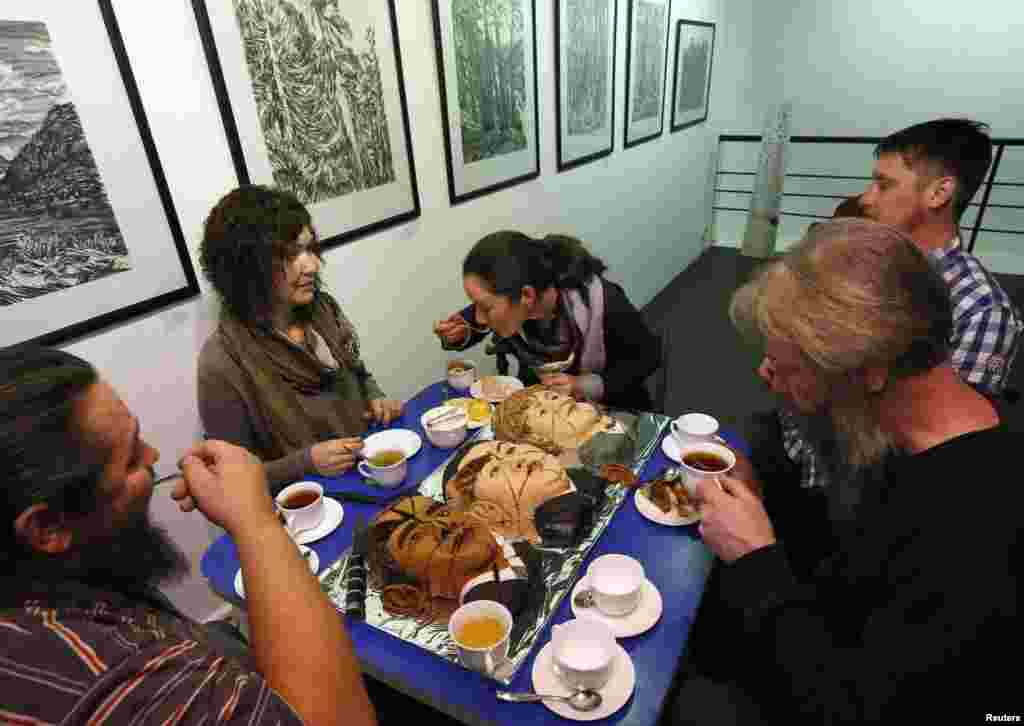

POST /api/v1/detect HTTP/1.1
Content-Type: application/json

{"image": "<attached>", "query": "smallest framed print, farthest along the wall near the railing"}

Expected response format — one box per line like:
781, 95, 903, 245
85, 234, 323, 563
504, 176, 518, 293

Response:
671, 20, 715, 132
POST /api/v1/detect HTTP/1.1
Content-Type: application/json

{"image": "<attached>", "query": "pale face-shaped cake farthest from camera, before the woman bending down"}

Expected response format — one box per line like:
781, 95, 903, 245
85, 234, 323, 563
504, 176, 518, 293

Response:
494, 386, 615, 456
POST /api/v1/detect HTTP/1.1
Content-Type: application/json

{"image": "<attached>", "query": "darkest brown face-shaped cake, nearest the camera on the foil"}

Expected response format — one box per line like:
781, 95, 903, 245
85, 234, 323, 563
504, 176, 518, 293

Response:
370, 496, 508, 600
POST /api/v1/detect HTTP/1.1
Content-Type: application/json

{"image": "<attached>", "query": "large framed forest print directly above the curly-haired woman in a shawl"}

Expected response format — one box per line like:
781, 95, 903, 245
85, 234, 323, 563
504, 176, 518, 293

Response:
193, 0, 420, 247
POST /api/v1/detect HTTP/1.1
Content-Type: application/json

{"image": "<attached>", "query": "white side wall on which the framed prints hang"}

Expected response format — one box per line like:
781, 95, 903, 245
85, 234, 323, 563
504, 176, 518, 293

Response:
59, 0, 755, 615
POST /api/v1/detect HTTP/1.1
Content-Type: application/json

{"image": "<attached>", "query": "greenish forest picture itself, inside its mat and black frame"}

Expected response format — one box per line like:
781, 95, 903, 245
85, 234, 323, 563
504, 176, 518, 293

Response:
452, 0, 527, 164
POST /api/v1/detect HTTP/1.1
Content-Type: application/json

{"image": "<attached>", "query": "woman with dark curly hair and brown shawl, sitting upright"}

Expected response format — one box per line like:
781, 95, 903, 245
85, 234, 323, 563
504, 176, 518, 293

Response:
199, 185, 401, 489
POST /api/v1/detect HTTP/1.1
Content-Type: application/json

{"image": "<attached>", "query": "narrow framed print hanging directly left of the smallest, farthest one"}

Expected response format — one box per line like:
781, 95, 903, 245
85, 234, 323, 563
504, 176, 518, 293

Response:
625, 0, 672, 148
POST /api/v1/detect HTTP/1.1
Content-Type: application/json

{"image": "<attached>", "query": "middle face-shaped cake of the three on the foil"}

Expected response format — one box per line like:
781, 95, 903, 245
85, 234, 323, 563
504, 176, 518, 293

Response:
444, 441, 575, 544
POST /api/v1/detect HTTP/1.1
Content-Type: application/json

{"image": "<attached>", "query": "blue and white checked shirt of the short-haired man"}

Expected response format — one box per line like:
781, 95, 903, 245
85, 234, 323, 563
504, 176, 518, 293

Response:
779, 237, 1024, 487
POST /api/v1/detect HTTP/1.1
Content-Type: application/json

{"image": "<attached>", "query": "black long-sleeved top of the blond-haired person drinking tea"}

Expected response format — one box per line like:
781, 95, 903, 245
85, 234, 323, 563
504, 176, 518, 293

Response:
722, 427, 1024, 724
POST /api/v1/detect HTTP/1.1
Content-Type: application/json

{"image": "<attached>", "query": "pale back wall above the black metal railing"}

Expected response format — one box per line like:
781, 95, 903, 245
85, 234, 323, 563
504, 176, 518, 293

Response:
755, 0, 1024, 136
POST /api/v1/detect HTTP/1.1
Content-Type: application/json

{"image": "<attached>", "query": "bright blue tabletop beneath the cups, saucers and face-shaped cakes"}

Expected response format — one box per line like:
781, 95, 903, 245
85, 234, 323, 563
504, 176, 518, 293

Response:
202, 383, 745, 726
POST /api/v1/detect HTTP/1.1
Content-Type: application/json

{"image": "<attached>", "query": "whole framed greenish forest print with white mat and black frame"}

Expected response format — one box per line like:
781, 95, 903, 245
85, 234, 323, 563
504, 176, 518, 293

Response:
434, 0, 541, 204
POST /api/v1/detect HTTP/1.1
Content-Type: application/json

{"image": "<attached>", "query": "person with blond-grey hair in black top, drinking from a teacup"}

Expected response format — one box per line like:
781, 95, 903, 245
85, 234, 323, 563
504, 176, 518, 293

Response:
679, 219, 1021, 723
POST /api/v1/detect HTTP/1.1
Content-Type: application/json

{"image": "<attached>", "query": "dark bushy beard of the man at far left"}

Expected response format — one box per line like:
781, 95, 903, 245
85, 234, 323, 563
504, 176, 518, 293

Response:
18, 514, 189, 592
